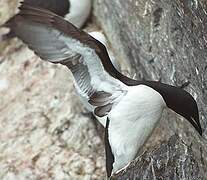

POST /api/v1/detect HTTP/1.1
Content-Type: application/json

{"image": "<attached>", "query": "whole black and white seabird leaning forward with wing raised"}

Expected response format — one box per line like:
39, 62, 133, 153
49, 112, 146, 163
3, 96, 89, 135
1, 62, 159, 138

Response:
9, 3, 202, 176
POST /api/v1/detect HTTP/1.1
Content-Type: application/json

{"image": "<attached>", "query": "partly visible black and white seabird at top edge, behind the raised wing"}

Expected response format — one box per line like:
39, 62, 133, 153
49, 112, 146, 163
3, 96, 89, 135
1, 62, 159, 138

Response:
0, 0, 91, 41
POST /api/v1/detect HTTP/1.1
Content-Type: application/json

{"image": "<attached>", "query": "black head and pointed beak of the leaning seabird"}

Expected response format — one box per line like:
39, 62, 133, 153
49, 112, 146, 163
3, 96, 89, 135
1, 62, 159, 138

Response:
143, 82, 202, 135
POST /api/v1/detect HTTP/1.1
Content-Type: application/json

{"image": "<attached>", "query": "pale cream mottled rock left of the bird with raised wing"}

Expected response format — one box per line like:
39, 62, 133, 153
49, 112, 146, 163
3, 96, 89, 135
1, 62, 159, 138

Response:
0, 0, 105, 180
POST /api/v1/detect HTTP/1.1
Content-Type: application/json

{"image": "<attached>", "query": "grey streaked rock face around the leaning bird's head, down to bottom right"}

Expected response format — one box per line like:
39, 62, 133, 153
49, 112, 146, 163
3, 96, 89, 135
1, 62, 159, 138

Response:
94, 0, 207, 180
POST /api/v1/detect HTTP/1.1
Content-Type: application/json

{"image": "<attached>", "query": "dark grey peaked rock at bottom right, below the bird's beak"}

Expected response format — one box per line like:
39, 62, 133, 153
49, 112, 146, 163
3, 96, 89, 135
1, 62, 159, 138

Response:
111, 135, 204, 180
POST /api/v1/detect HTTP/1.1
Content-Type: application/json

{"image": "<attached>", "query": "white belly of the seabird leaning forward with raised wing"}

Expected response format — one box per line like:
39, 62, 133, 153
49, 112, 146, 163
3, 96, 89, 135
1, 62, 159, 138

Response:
108, 85, 166, 172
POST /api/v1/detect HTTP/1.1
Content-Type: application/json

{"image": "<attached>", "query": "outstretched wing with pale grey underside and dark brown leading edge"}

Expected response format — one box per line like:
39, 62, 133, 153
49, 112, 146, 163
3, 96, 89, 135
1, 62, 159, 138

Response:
13, 3, 125, 117
